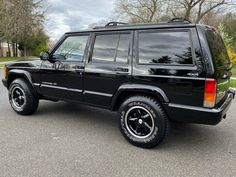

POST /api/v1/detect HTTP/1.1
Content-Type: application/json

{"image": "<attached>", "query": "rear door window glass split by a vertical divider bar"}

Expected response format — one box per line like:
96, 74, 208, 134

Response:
92, 34, 130, 63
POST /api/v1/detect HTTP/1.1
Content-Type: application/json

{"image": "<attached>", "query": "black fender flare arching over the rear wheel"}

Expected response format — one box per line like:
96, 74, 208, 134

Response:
111, 84, 169, 110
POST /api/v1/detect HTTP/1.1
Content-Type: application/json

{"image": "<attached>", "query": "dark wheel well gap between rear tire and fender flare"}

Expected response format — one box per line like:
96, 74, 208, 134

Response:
113, 91, 166, 111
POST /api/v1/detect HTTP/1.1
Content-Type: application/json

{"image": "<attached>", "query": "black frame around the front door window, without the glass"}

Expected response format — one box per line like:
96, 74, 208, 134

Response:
50, 33, 91, 64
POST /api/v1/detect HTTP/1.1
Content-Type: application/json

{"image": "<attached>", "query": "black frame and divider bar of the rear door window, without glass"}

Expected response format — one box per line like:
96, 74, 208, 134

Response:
88, 30, 133, 65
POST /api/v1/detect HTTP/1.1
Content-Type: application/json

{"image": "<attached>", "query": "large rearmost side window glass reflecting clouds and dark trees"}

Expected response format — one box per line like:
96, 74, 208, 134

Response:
139, 32, 193, 65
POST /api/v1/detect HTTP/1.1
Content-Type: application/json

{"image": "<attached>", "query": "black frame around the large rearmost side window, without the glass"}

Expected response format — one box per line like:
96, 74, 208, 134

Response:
135, 29, 196, 67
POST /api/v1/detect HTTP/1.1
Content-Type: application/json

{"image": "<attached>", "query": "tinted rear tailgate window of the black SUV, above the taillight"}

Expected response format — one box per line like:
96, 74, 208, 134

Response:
206, 30, 230, 67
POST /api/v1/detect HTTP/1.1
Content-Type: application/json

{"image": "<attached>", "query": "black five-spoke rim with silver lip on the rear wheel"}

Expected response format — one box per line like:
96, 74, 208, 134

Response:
125, 106, 155, 139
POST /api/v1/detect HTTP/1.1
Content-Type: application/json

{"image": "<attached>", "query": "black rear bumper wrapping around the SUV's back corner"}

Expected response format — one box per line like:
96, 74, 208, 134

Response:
169, 90, 235, 125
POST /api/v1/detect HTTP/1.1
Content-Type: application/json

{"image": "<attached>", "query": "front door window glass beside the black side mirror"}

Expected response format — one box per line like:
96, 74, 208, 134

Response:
53, 36, 88, 62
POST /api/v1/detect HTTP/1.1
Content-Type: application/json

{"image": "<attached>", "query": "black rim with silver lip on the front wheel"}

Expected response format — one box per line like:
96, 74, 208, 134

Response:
11, 87, 25, 109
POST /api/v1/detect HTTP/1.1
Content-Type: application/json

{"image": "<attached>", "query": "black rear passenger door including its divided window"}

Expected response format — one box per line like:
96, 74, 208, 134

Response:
84, 31, 132, 107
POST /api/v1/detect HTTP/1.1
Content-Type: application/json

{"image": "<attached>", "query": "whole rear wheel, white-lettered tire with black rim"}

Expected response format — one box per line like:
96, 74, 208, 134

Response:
119, 96, 169, 148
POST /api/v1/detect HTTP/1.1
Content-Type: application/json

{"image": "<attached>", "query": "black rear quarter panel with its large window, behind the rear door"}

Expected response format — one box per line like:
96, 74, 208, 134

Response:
133, 27, 205, 106
